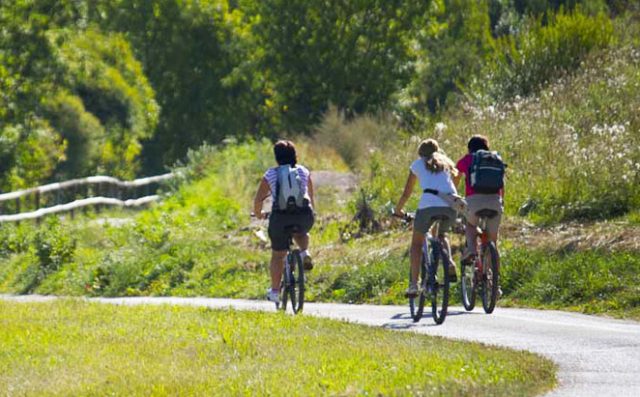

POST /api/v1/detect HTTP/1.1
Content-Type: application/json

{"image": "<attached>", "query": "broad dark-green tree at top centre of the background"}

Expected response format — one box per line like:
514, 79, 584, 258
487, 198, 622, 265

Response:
241, 0, 429, 132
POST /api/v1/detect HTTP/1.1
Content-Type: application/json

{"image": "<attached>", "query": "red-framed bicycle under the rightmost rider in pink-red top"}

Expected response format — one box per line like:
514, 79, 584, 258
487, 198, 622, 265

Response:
460, 209, 500, 314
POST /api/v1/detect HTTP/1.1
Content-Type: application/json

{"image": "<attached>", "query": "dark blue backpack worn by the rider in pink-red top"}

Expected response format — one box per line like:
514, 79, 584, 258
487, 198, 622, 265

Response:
469, 150, 506, 194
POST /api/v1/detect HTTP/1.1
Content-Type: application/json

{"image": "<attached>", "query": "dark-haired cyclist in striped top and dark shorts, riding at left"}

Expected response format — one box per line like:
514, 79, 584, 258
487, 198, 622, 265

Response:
253, 140, 315, 303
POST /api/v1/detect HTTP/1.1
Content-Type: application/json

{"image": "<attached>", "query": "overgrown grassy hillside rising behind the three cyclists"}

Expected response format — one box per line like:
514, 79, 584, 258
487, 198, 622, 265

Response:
0, 2, 640, 318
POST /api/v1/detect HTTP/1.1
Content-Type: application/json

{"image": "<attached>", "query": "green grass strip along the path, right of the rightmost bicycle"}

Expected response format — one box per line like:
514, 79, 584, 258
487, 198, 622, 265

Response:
502, 248, 640, 320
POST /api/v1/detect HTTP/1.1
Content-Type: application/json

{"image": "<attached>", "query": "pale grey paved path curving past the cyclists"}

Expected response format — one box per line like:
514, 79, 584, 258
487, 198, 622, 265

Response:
0, 296, 640, 397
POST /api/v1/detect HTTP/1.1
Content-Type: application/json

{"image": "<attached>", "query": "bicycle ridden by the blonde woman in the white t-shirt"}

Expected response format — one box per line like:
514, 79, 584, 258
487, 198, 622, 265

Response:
396, 214, 450, 325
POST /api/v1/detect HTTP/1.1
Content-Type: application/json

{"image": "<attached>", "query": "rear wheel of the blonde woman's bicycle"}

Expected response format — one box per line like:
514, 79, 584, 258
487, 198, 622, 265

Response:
429, 241, 449, 324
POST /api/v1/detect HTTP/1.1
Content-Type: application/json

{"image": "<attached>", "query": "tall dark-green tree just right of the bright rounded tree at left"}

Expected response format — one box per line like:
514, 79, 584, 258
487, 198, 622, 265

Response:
89, 0, 259, 172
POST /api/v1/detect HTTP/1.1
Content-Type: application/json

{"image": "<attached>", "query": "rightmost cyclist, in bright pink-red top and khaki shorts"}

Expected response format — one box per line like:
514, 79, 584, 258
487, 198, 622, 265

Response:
454, 135, 504, 262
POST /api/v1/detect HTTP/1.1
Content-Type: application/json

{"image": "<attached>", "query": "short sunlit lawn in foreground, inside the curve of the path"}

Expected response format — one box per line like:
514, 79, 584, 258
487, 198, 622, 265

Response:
0, 300, 555, 396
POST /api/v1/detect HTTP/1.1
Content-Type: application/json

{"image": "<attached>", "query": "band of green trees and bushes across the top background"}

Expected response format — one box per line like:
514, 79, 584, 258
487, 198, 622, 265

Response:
0, 0, 638, 183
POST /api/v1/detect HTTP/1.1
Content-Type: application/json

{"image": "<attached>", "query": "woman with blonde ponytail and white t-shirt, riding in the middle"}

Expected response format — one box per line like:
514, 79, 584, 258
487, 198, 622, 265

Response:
394, 139, 458, 297
